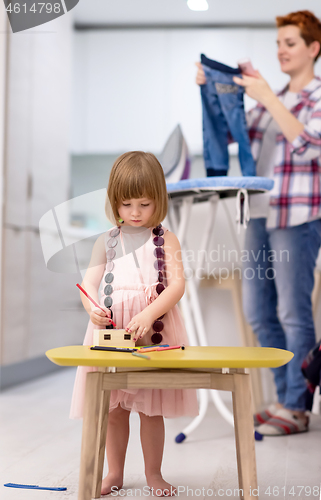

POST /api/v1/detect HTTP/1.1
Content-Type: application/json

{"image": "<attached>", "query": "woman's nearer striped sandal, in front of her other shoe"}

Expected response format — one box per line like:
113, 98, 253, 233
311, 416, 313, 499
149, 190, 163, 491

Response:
257, 408, 309, 436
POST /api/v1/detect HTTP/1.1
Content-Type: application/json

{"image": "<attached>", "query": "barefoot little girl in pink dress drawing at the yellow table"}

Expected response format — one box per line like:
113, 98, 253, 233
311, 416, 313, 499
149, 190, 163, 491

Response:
70, 151, 198, 495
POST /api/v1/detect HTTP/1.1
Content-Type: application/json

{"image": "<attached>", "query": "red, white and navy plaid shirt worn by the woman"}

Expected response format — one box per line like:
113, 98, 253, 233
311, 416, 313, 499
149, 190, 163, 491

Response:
247, 77, 321, 228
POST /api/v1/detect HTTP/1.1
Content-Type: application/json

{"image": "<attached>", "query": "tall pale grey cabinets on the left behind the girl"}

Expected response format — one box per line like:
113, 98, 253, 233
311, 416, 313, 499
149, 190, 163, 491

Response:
1, 16, 88, 364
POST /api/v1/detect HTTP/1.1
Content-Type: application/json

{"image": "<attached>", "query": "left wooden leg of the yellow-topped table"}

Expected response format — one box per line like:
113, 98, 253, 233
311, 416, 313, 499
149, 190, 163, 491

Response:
78, 372, 110, 500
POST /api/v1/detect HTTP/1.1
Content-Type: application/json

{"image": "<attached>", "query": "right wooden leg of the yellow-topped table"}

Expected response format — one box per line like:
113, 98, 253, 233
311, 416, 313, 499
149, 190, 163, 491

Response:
232, 373, 258, 500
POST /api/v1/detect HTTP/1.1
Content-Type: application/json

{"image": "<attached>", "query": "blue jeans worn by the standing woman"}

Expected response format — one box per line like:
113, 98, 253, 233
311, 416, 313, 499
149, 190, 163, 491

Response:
242, 219, 321, 411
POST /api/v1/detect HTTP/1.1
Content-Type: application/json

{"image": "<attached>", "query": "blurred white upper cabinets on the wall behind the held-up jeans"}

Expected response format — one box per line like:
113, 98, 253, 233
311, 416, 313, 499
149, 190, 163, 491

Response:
71, 29, 320, 153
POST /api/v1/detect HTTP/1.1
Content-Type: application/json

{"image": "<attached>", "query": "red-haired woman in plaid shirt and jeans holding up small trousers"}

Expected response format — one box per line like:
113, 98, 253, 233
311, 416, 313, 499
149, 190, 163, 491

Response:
196, 10, 321, 435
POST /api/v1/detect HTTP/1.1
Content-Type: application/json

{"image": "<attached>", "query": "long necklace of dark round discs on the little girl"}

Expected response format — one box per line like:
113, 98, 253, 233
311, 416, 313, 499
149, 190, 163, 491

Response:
104, 224, 165, 344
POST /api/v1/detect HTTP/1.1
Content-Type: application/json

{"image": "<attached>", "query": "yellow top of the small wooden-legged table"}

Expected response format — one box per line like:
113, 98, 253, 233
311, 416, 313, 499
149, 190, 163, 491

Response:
46, 345, 293, 368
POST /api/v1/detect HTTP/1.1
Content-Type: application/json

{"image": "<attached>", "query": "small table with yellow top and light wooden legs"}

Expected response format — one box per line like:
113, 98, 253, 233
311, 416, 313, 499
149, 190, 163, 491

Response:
46, 346, 293, 500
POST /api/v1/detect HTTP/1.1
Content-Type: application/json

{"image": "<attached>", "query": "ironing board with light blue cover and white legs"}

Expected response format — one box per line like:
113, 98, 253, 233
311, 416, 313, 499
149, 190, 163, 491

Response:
167, 177, 274, 443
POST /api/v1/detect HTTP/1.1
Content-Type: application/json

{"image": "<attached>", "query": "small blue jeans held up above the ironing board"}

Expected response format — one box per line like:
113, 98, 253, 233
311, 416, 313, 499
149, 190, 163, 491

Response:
201, 54, 255, 177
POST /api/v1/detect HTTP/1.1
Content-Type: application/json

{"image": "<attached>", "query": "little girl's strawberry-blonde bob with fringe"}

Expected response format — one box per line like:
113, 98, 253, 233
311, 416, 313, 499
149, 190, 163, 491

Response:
105, 151, 168, 227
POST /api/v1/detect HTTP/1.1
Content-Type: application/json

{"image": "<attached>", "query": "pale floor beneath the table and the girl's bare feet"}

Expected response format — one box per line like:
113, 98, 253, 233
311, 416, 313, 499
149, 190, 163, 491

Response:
0, 369, 321, 500
